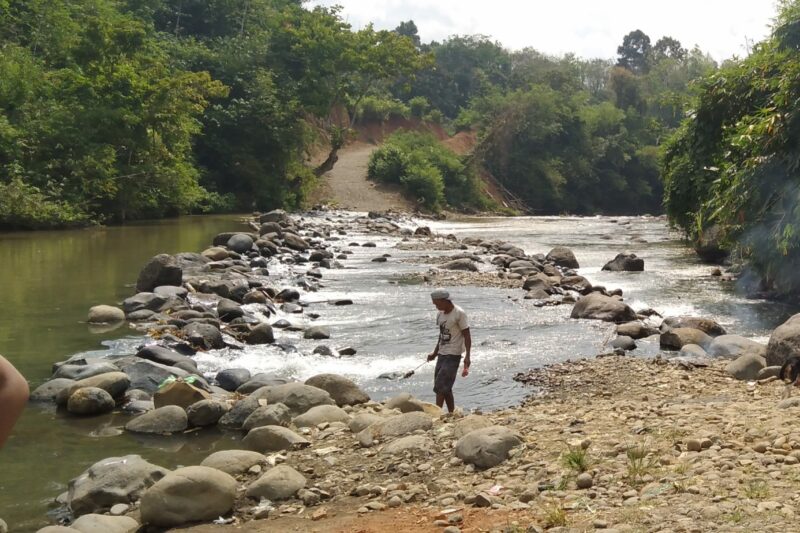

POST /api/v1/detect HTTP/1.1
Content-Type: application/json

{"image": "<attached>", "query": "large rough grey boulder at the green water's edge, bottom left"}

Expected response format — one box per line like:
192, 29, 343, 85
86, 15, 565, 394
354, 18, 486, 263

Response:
67, 455, 169, 516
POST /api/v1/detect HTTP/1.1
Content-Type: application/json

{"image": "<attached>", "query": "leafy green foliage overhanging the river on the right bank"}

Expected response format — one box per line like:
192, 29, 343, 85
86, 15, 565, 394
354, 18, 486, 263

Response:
663, 0, 800, 294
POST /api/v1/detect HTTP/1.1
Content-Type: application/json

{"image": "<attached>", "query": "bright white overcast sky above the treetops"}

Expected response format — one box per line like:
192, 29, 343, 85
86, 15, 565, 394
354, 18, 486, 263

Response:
307, 0, 776, 61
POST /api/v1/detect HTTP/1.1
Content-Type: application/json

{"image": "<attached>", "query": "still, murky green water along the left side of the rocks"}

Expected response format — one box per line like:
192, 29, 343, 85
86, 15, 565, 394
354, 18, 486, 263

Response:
0, 215, 250, 531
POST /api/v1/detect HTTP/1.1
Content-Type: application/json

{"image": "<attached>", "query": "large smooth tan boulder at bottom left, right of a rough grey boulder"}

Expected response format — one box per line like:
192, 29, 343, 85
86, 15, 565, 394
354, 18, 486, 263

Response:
140, 466, 237, 527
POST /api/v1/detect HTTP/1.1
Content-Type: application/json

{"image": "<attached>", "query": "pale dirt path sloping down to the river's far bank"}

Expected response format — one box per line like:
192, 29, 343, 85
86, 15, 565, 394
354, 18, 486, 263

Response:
313, 142, 414, 211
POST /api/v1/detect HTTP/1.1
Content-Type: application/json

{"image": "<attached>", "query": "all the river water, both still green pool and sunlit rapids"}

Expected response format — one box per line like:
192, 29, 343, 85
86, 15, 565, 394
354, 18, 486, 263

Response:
0, 212, 794, 531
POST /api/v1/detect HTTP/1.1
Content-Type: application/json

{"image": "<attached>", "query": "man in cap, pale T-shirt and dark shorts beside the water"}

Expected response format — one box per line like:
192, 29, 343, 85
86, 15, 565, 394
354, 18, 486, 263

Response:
428, 289, 472, 413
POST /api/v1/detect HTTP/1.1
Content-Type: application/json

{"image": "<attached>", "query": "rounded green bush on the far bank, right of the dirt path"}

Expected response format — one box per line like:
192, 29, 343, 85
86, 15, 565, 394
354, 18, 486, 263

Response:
368, 131, 486, 211
